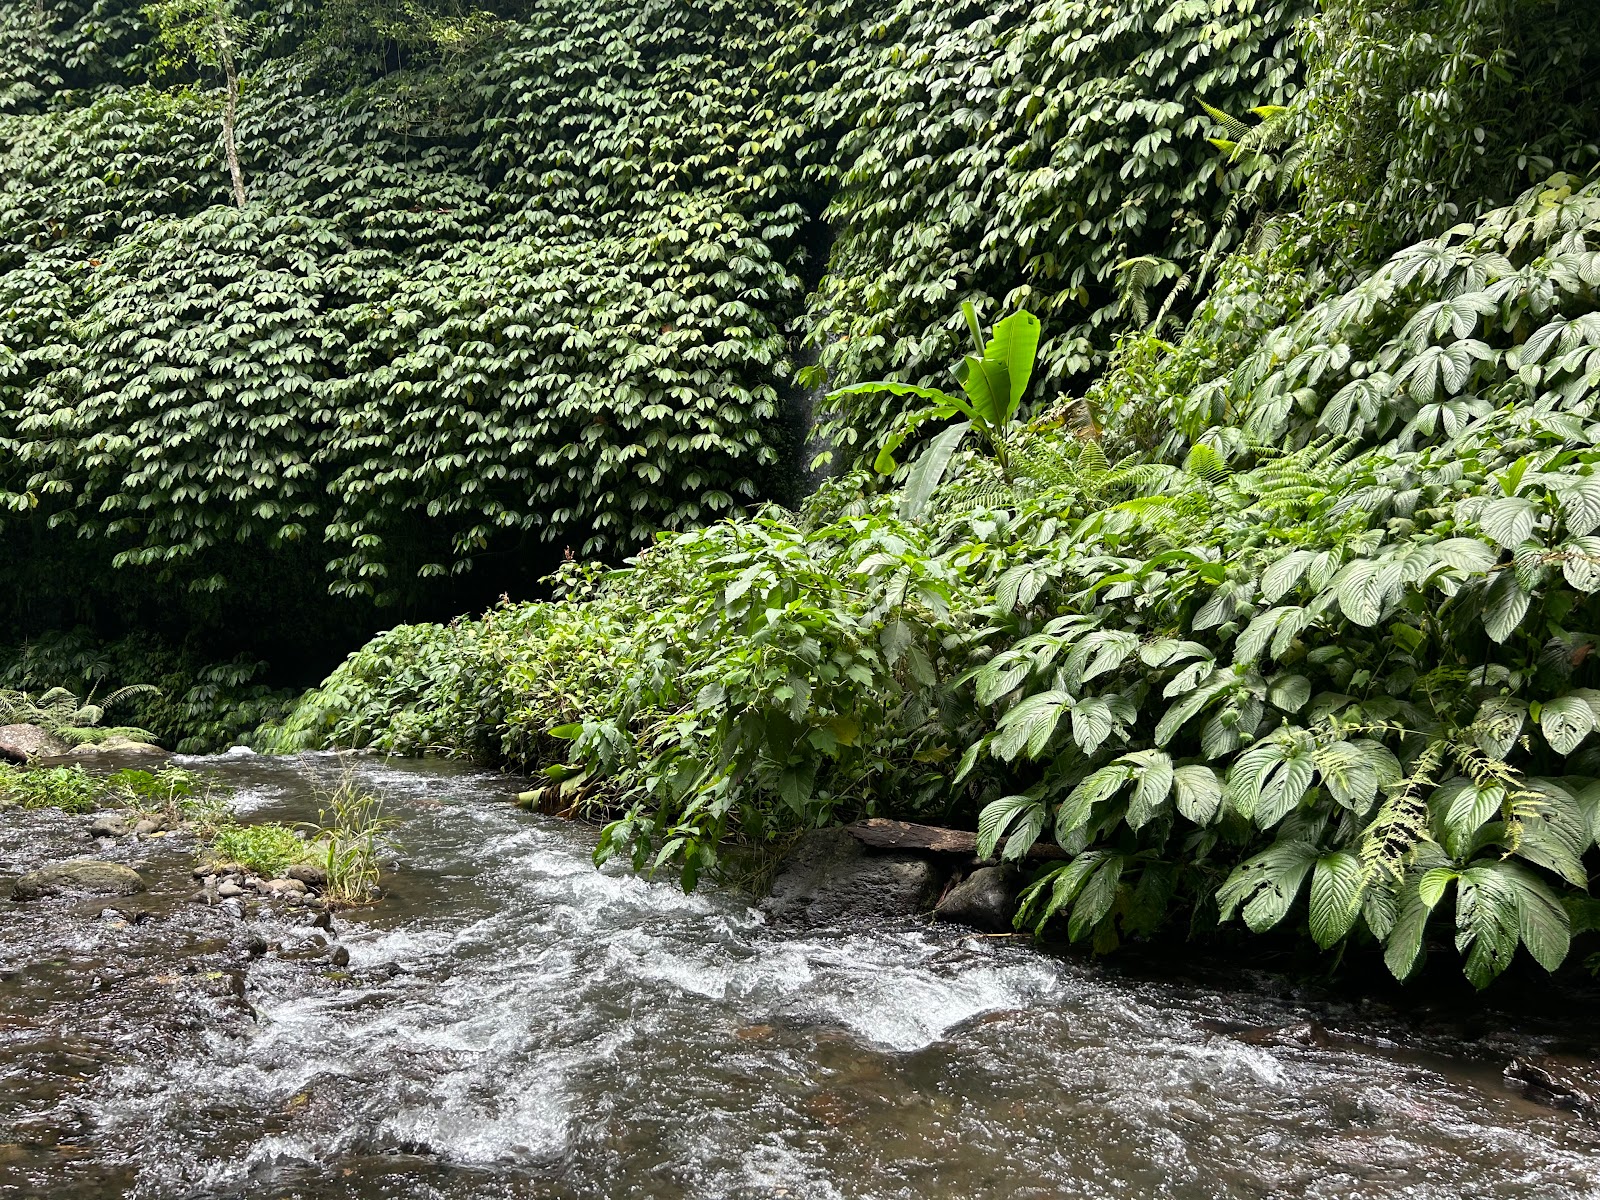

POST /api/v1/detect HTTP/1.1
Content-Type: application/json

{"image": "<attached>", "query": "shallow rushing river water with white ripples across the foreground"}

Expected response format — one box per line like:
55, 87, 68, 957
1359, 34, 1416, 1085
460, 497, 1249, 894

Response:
0, 755, 1600, 1200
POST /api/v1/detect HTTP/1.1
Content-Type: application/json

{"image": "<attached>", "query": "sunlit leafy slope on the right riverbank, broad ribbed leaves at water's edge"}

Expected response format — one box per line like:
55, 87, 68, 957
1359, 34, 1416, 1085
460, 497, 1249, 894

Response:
270, 3, 1600, 986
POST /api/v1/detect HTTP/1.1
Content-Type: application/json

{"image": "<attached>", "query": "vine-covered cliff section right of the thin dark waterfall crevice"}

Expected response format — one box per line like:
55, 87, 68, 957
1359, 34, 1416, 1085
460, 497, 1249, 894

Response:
810, 0, 1310, 461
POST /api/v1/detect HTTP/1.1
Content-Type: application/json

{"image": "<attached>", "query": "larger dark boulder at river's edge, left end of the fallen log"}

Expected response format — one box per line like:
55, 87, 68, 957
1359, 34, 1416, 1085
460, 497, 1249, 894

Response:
762, 829, 939, 925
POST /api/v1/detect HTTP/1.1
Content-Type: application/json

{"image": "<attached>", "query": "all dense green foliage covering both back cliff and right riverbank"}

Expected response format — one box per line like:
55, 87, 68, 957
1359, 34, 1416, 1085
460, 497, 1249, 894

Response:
9, 0, 1600, 986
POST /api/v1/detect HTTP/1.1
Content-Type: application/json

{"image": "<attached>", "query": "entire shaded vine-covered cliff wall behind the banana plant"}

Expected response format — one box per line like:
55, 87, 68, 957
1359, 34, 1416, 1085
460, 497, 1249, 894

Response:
0, 0, 1324, 672
